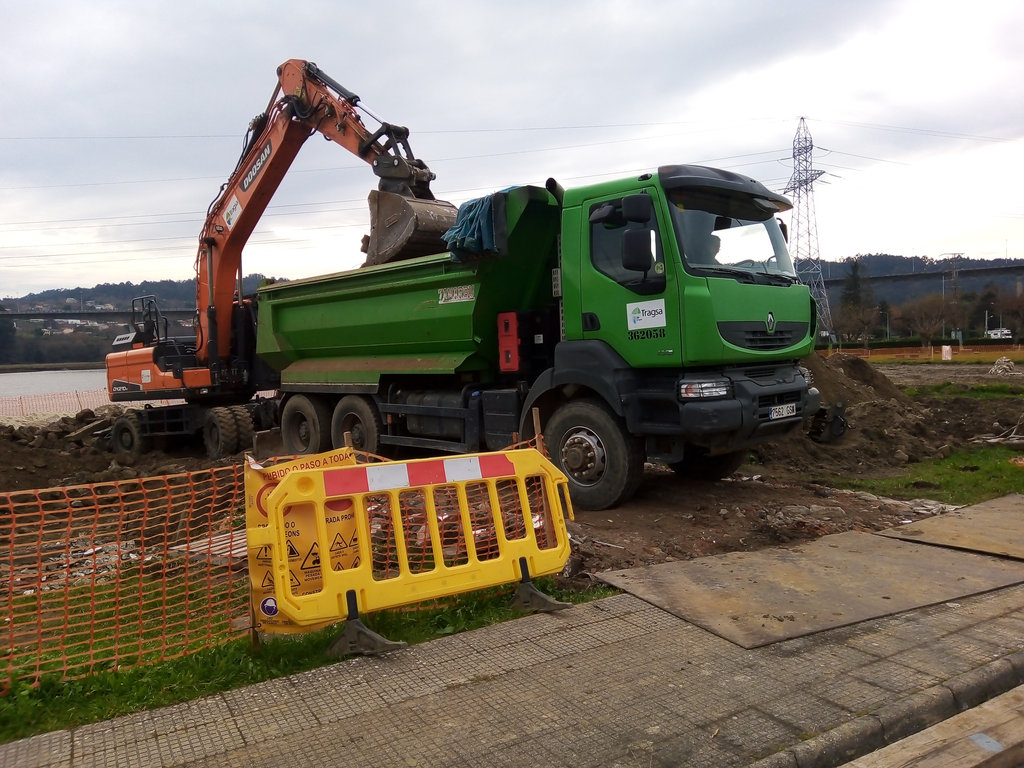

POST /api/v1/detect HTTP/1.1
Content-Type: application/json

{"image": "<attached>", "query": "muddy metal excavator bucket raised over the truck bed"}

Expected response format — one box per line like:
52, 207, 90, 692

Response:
362, 189, 459, 266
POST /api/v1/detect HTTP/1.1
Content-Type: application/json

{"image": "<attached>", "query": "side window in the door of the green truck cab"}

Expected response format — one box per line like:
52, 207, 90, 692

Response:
590, 199, 665, 295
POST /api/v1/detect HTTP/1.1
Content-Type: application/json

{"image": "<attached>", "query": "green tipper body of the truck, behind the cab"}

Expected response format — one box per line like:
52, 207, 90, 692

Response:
256, 186, 559, 390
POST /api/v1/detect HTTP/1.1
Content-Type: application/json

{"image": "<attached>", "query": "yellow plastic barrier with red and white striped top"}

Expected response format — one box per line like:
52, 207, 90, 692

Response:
247, 449, 572, 647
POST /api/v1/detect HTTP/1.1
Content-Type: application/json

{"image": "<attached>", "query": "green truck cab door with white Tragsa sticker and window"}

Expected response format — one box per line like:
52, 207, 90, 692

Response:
581, 195, 681, 368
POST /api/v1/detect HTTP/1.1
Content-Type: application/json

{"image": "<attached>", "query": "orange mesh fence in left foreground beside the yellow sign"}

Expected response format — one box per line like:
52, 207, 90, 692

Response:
0, 466, 249, 691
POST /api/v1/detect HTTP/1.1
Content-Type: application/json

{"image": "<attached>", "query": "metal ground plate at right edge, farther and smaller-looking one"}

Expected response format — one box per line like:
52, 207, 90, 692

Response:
880, 493, 1024, 560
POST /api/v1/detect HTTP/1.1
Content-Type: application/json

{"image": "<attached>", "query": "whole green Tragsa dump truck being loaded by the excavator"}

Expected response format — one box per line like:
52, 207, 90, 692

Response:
256, 165, 818, 509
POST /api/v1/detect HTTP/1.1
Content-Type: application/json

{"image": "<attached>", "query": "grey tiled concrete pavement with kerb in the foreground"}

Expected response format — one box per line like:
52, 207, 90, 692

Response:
0, 563, 1024, 768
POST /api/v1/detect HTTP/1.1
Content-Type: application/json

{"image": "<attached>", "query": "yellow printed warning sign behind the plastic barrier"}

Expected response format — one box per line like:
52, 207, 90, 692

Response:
245, 449, 358, 634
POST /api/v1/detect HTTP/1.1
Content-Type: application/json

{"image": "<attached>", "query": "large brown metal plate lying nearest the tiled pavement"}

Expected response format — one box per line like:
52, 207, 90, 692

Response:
599, 531, 1024, 648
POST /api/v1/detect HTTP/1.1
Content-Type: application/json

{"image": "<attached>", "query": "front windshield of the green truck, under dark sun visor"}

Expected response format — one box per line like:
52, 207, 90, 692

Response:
669, 189, 797, 282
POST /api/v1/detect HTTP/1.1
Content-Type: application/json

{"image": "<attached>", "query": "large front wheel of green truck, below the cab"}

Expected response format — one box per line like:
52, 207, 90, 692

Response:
544, 400, 643, 510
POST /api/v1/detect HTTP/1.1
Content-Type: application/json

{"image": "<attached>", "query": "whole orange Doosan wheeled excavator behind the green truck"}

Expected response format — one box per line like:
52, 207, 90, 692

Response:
106, 59, 457, 462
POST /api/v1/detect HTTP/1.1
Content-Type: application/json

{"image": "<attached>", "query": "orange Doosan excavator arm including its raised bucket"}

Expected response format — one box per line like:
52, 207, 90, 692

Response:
196, 59, 457, 388
